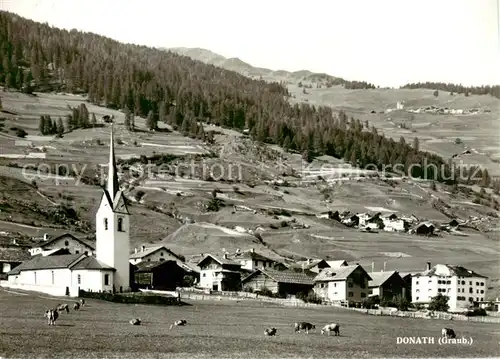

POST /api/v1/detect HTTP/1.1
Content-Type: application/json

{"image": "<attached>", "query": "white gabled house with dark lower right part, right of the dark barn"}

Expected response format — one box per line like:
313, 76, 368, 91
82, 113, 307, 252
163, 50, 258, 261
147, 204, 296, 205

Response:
197, 254, 241, 291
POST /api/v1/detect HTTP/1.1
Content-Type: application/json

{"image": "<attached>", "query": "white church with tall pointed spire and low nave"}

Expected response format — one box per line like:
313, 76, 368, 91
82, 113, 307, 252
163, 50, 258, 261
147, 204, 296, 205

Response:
2, 128, 131, 297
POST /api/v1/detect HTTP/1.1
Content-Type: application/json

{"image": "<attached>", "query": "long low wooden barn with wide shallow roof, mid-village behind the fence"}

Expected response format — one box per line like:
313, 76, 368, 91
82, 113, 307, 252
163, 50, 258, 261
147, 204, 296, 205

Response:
241, 269, 314, 296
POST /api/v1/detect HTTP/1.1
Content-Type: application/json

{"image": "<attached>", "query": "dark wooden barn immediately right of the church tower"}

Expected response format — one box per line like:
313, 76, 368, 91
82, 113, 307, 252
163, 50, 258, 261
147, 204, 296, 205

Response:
134, 260, 198, 290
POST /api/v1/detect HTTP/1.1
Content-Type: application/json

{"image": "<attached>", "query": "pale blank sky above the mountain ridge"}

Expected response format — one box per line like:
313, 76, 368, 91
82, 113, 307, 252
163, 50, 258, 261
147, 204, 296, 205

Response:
0, 0, 500, 87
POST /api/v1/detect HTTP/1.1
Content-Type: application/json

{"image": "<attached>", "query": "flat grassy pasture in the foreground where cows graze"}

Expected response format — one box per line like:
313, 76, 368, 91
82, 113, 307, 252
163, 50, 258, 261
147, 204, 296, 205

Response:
0, 290, 500, 358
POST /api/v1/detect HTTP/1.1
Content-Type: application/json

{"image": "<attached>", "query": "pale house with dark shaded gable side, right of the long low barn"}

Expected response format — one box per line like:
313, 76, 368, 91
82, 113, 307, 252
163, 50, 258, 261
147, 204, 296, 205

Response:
314, 264, 372, 303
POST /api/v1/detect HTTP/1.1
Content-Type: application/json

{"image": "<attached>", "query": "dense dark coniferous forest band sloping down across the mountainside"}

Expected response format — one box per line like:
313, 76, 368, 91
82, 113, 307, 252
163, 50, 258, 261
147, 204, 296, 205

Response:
0, 12, 494, 186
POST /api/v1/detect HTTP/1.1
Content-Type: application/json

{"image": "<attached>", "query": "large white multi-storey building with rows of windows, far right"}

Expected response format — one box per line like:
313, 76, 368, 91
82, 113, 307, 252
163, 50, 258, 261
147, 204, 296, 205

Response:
412, 263, 488, 311
